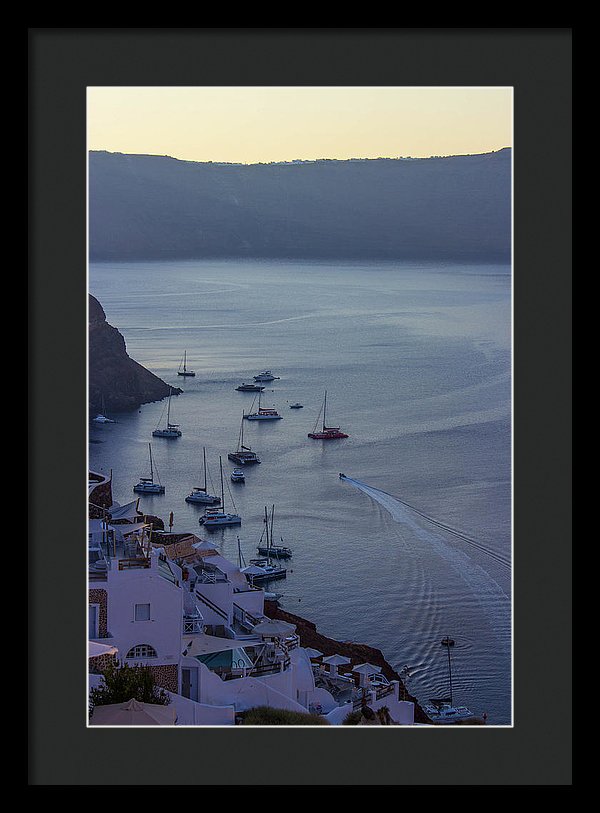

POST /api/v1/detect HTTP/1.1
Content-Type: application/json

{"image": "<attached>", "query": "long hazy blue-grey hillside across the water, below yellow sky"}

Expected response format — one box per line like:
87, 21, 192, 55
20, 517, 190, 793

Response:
89, 147, 511, 260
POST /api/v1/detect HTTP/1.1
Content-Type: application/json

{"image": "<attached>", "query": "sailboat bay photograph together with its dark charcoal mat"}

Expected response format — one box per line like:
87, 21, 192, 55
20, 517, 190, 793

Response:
30, 29, 571, 785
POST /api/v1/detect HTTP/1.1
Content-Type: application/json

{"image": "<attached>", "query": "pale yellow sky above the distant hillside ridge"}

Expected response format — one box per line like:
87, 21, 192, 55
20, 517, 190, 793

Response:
87, 86, 513, 164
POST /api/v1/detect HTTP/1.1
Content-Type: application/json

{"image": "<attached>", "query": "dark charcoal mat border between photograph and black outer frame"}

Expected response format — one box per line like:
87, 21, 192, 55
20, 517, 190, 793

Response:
28, 28, 572, 786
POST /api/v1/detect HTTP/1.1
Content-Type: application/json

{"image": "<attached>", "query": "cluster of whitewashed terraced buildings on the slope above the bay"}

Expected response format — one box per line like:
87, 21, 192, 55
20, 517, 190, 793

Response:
89, 498, 414, 725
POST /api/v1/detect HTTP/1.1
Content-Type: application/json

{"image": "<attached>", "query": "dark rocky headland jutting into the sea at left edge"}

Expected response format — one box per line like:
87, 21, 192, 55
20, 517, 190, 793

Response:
89, 294, 182, 414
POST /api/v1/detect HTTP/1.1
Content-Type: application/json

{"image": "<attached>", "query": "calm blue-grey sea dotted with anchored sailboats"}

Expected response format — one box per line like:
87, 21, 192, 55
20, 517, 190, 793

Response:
89, 260, 511, 725
